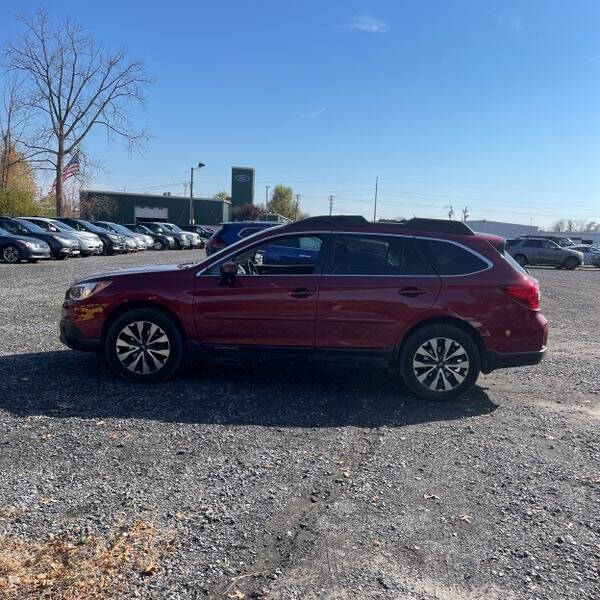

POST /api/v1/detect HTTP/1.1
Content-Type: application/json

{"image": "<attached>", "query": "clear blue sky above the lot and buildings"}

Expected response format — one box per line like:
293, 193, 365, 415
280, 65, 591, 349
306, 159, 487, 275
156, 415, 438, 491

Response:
1, 0, 600, 225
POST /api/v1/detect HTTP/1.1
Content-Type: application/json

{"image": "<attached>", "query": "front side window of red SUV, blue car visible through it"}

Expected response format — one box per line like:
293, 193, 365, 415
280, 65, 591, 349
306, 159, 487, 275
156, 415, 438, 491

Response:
208, 235, 323, 276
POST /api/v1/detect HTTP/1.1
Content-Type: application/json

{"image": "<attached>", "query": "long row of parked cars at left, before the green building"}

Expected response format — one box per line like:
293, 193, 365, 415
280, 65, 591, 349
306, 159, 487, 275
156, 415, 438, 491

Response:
0, 216, 214, 263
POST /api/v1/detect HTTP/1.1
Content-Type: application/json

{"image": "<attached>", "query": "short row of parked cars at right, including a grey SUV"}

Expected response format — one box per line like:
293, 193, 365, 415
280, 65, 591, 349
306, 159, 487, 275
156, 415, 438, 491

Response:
506, 235, 600, 271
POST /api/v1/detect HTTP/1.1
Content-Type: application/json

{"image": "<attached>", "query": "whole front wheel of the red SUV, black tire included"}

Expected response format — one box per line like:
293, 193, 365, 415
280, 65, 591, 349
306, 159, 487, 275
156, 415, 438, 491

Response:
104, 308, 184, 382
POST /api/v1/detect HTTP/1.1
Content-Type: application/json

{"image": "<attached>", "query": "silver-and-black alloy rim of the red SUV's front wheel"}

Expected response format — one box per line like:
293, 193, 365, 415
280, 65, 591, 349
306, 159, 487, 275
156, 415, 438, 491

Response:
115, 321, 171, 375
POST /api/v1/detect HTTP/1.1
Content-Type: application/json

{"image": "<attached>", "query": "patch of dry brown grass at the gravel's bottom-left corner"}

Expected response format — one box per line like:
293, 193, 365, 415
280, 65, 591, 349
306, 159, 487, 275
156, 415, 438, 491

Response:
0, 522, 174, 600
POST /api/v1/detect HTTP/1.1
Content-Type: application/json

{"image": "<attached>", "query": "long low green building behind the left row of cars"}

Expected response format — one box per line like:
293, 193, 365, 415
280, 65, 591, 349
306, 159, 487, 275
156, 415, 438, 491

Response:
79, 190, 231, 226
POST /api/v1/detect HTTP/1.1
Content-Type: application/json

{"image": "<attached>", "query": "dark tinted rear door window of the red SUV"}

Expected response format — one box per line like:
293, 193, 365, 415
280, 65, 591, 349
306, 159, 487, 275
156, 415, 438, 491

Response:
330, 235, 433, 275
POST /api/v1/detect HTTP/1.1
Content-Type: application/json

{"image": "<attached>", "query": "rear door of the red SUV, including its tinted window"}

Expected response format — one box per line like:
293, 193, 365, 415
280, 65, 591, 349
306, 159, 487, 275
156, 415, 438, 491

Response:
316, 233, 441, 351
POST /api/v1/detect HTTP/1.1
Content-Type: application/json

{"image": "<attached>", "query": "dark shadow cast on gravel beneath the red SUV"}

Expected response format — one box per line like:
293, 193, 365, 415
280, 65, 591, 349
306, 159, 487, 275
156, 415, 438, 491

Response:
0, 351, 497, 427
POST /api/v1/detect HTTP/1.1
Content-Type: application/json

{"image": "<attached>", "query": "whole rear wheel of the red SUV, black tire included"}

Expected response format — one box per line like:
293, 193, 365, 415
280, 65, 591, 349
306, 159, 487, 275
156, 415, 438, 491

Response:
400, 324, 481, 402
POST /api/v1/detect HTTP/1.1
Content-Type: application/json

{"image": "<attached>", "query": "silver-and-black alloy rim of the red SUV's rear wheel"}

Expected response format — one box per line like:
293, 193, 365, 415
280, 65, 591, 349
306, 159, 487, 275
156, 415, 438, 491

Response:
413, 337, 469, 392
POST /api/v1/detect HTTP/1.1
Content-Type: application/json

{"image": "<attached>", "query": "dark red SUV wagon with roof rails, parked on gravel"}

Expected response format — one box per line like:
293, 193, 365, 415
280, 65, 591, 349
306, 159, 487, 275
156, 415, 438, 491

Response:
60, 216, 548, 400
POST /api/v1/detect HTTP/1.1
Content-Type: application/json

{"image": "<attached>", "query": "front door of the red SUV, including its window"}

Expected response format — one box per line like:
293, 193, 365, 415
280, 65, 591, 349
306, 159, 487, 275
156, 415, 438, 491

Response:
194, 234, 328, 348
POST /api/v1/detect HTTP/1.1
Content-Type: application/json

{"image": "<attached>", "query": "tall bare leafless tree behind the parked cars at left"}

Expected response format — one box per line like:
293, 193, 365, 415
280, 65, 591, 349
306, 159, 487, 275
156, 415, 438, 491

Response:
4, 11, 152, 216
